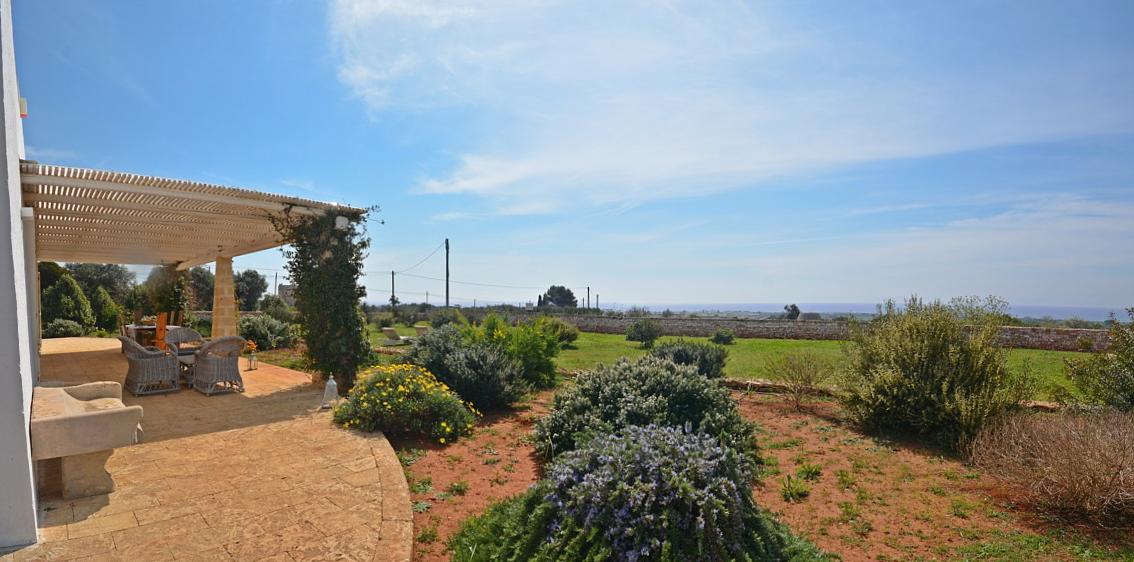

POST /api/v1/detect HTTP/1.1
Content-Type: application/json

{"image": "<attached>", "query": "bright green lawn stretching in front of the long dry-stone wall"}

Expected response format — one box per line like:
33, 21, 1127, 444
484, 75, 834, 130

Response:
557, 332, 1083, 399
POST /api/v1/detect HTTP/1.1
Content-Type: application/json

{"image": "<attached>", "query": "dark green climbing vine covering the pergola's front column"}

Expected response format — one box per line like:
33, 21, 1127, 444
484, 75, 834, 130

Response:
272, 205, 374, 393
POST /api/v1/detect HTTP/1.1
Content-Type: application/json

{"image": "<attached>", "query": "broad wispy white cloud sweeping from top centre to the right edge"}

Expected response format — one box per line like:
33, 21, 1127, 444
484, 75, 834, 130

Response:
331, 0, 1134, 214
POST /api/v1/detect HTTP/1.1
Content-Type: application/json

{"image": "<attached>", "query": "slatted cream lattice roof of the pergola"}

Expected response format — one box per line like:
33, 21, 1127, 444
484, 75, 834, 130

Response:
19, 161, 361, 269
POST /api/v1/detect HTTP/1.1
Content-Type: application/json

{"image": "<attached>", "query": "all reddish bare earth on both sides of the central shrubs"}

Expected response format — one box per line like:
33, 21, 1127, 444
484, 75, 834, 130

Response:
390, 391, 1134, 562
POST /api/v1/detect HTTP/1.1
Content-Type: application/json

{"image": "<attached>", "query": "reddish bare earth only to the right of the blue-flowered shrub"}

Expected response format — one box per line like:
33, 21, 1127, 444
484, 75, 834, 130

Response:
734, 392, 1134, 561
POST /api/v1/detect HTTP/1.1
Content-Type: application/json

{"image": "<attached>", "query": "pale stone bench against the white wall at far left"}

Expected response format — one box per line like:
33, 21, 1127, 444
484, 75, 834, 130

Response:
31, 382, 142, 500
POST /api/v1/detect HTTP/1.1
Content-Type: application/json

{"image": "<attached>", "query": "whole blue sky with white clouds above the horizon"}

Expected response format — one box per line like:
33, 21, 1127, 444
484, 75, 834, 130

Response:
14, 0, 1134, 307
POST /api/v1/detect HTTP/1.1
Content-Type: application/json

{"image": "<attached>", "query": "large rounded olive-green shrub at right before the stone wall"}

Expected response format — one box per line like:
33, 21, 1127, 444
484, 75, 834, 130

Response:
843, 298, 1031, 449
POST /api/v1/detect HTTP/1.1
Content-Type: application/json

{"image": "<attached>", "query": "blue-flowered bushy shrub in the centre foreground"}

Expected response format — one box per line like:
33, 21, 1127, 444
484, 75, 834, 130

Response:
449, 426, 822, 561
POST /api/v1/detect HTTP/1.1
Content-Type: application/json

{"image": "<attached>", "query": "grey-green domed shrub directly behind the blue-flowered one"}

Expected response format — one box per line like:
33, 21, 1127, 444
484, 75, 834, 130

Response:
535, 357, 756, 458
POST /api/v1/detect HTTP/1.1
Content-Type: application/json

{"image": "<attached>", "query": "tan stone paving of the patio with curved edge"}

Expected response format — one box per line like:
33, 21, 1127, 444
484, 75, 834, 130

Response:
0, 338, 413, 562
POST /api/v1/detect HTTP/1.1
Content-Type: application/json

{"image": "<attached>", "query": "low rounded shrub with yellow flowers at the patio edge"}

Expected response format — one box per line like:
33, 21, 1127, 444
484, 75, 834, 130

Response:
335, 365, 479, 443
